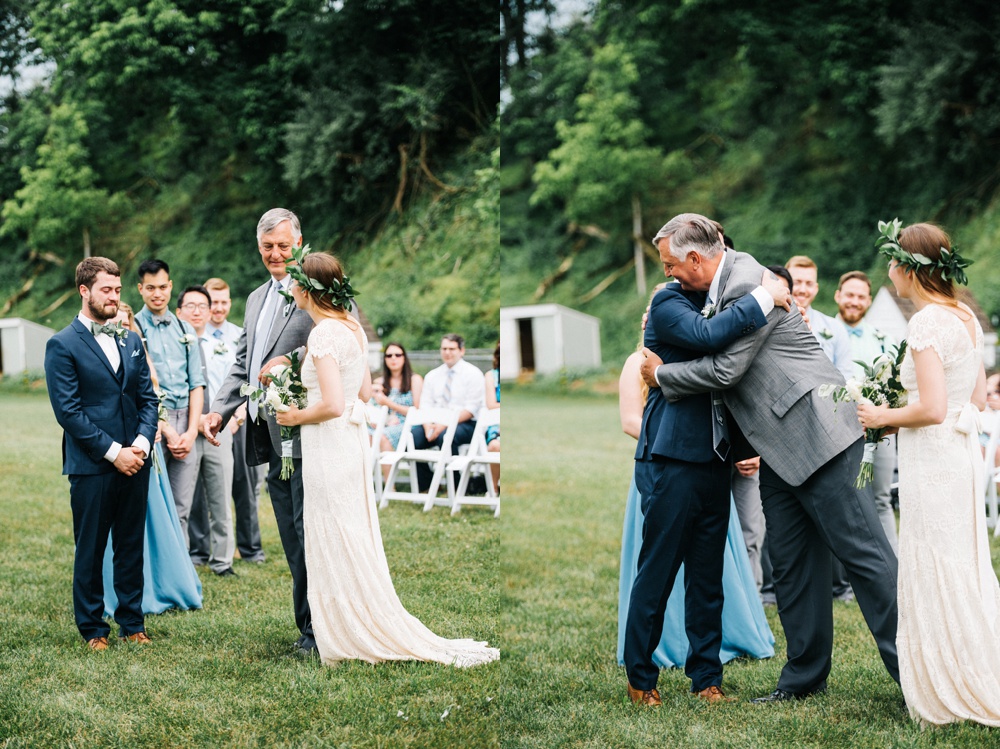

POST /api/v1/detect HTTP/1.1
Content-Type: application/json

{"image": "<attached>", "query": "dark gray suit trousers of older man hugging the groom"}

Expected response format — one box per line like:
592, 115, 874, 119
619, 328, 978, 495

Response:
760, 438, 899, 694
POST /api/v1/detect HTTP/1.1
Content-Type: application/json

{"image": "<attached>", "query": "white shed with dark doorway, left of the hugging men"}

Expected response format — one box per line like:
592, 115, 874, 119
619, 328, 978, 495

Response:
500, 304, 601, 380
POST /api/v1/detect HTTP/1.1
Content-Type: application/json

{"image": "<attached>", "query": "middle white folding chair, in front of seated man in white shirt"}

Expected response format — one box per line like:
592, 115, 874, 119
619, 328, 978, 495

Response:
379, 406, 458, 512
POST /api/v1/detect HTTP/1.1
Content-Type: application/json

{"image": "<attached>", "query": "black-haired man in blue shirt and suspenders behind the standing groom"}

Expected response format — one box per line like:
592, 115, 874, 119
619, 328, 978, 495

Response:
135, 260, 205, 542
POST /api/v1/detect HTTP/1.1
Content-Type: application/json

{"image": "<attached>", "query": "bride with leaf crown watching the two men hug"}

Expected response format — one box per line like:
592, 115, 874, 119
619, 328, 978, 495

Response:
858, 224, 1000, 726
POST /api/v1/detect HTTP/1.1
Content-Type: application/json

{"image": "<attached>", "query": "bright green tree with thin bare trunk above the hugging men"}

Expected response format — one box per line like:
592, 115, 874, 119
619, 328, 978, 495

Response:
532, 44, 667, 295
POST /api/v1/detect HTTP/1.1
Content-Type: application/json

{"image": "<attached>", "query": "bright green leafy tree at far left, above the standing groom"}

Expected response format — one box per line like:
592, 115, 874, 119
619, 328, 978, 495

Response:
0, 104, 128, 259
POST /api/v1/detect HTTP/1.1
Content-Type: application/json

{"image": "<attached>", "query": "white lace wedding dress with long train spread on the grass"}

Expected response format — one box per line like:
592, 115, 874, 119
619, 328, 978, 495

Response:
302, 320, 500, 667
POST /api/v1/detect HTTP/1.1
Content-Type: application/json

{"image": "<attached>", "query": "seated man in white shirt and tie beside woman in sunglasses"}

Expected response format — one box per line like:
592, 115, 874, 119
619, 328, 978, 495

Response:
413, 333, 486, 491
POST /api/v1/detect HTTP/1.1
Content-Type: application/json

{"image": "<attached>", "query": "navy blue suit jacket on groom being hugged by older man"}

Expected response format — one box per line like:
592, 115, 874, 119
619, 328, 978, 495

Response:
635, 283, 767, 463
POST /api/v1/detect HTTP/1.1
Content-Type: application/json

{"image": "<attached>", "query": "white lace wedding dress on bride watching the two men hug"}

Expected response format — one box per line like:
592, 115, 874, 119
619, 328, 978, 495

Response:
896, 305, 1000, 726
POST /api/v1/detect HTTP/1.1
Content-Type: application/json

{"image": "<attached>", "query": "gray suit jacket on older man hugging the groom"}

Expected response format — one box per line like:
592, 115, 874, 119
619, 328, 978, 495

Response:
656, 250, 862, 486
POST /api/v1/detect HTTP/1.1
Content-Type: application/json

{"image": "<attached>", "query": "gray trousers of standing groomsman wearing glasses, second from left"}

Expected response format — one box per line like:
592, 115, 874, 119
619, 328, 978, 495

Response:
188, 429, 236, 573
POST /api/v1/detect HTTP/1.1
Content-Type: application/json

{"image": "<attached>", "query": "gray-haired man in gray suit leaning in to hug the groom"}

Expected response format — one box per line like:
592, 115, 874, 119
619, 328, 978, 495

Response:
641, 213, 899, 703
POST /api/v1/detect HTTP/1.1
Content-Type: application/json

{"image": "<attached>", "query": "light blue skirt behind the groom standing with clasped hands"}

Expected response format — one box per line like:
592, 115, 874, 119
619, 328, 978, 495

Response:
104, 443, 201, 616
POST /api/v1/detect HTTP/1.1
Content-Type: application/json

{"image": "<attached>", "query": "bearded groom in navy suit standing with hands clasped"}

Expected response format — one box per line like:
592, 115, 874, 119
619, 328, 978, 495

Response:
45, 257, 157, 650
